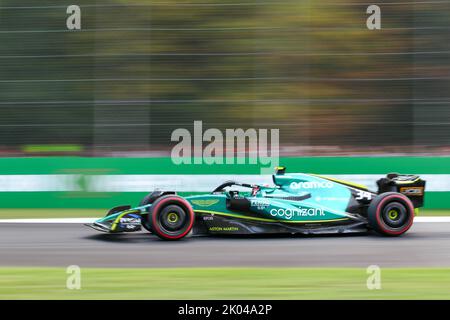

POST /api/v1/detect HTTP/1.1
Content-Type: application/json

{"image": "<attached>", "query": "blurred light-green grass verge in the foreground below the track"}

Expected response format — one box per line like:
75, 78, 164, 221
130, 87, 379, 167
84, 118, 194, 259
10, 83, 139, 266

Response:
0, 268, 450, 299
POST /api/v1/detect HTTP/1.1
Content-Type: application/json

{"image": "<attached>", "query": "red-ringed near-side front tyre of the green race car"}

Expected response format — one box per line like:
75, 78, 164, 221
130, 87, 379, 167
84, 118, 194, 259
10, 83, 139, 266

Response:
149, 195, 195, 240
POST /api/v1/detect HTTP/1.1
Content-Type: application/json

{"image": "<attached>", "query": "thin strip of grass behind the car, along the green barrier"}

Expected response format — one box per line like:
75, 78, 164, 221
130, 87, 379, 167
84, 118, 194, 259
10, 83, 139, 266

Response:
0, 209, 450, 219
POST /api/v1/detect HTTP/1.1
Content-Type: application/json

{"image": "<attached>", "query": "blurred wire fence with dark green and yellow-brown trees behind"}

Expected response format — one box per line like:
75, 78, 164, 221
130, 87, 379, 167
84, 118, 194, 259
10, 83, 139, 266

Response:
0, 0, 450, 154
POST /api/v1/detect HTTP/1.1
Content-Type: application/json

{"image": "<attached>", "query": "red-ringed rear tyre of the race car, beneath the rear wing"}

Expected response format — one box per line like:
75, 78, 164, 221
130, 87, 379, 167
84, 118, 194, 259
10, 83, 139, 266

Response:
367, 192, 414, 236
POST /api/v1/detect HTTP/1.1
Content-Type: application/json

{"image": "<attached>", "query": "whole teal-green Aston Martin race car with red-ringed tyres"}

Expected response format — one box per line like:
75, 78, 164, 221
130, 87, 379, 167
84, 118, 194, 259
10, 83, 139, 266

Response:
88, 167, 425, 240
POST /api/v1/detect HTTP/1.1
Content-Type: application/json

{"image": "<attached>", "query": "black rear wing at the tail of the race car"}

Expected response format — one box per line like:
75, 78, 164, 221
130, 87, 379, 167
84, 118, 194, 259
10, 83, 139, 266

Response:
377, 173, 425, 208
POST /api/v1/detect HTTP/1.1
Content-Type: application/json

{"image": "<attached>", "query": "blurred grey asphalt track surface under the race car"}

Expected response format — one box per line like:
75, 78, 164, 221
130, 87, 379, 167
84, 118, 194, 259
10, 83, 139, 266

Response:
0, 223, 450, 267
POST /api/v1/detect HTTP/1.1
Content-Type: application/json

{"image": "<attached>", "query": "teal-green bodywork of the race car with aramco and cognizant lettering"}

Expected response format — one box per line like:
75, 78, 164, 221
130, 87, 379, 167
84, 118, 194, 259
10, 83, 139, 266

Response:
97, 173, 373, 232
